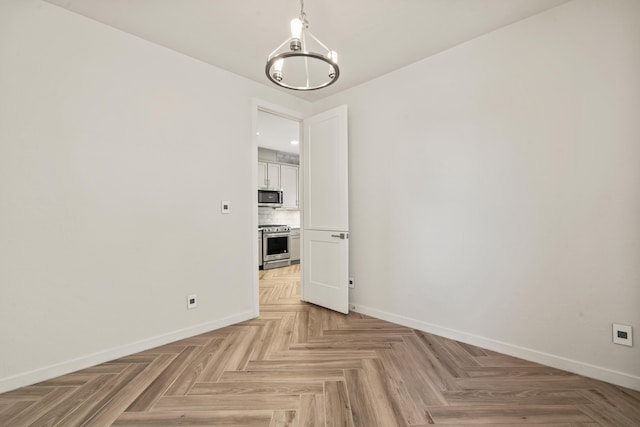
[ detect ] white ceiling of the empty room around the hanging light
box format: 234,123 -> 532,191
46,0 -> 568,101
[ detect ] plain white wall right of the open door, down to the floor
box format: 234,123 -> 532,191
314,0 -> 640,389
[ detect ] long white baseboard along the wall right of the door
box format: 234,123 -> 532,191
353,303 -> 640,391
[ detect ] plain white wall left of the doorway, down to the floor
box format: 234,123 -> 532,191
0,0 -> 310,392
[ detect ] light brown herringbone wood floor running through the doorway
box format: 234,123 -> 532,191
0,265 -> 640,427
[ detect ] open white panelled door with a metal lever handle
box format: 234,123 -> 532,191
301,105 -> 349,313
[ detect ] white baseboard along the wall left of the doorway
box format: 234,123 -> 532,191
0,310 -> 256,393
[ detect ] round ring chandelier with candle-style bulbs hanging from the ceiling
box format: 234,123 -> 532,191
265,0 -> 340,91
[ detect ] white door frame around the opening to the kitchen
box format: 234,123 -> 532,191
250,98 -> 310,317
